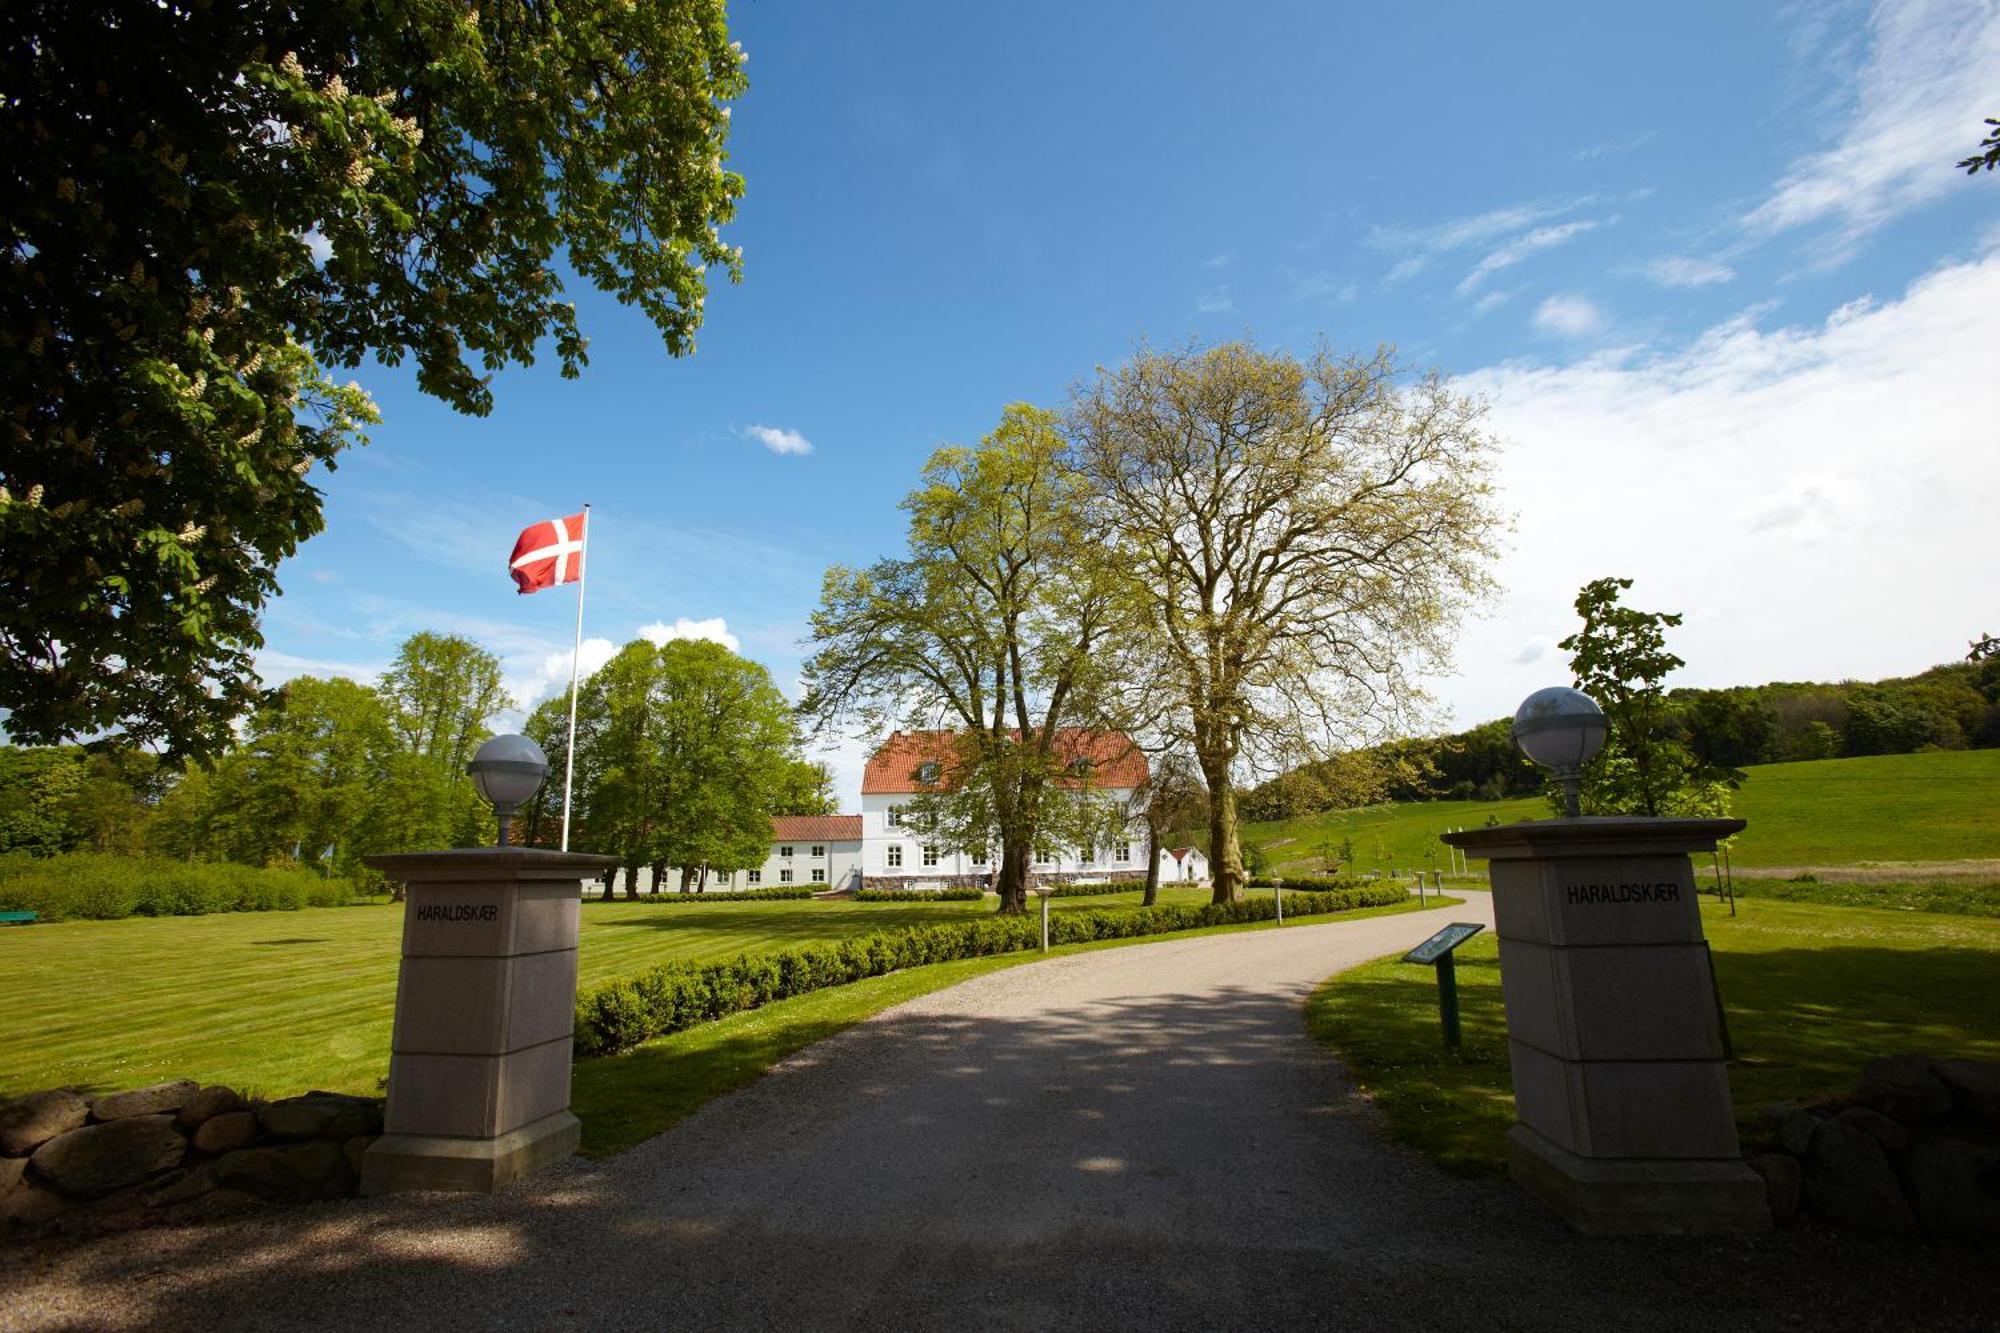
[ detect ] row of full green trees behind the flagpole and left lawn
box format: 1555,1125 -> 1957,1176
0,632 -> 832,887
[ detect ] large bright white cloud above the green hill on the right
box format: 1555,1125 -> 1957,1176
1440,252 -> 2000,723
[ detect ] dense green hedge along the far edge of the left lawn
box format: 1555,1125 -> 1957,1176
0,853 -> 356,921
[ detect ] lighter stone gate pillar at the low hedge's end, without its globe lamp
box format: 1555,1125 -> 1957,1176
362,847 -> 614,1195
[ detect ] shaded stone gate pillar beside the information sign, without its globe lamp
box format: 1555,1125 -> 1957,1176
1444,819 -> 1770,1233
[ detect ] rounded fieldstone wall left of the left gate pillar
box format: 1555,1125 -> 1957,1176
0,1079 -> 382,1229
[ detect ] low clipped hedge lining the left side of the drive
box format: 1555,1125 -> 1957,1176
576,885 -> 1410,1057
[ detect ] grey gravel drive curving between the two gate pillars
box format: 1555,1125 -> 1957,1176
0,895 -> 2000,1333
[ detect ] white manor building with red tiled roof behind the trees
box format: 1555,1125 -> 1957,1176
708,731 -> 1208,893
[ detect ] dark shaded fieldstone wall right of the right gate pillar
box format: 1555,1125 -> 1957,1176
1750,1055 -> 2000,1237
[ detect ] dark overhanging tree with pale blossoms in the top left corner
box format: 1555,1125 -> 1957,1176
0,0 -> 746,757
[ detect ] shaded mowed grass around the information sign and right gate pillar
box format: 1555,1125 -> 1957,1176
1306,899 -> 2000,1175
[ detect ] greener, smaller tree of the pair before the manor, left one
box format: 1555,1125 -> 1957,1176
800,402 -> 1122,913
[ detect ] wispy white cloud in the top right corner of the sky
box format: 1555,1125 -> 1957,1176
1744,0 -> 2000,249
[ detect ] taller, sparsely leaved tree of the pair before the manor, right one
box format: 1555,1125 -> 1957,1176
1068,342 -> 1502,903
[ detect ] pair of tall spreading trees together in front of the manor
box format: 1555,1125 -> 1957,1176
802,342 -> 1502,911
